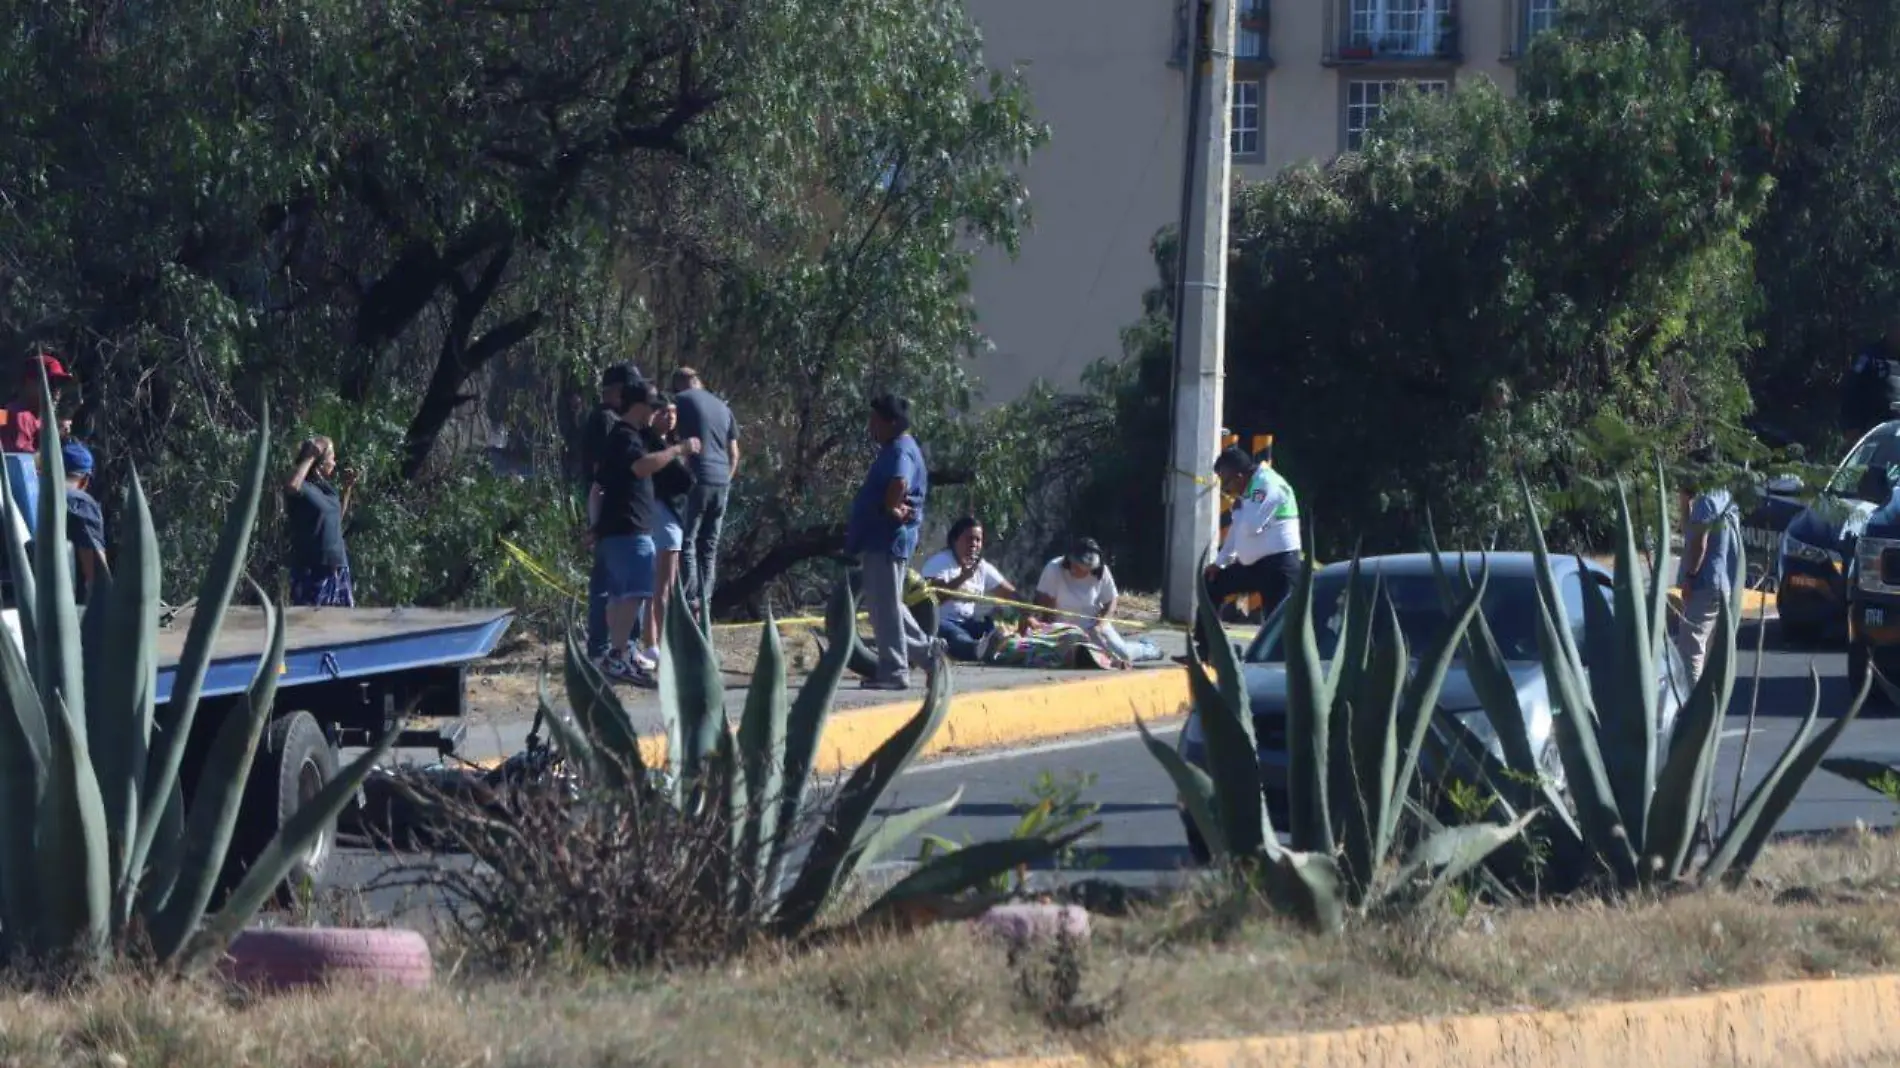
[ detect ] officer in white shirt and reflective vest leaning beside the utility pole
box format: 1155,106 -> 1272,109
1195,445 -> 1305,656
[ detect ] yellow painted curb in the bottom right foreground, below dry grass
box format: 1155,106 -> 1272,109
946,975 -> 1900,1068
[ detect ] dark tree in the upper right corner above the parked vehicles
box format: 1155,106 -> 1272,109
1571,0 -> 1900,444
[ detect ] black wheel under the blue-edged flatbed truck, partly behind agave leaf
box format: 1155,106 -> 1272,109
232,713 -> 336,903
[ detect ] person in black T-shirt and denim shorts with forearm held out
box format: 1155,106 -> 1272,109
593,382 -> 699,684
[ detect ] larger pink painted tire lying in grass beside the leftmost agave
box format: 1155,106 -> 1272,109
222,927 -> 435,990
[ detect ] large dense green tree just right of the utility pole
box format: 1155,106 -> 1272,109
1094,34 -> 1767,559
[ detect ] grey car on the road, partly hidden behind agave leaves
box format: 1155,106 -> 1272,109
1176,553 -> 1687,863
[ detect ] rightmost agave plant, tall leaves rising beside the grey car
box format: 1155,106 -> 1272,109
1427,475 -> 1866,889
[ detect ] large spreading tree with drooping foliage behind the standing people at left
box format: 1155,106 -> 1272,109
0,0 -> 1045,604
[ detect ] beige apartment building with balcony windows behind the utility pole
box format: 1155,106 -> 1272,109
967,0 -> 1560,403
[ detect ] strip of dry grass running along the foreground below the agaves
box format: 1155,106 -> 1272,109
11,834 -> 1900,1068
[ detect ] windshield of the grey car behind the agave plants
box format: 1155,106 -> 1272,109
1246,570 -> 1583,663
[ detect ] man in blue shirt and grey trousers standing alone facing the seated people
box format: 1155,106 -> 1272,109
844,393 -> 937,690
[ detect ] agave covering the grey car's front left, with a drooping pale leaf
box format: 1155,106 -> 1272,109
1136,551 -> 1535,929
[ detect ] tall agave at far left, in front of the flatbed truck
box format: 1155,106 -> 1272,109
0,390 -> 395,971
